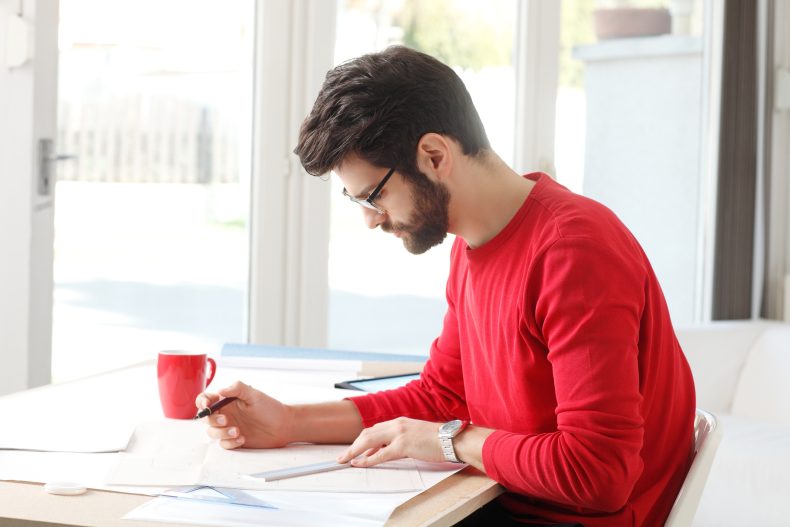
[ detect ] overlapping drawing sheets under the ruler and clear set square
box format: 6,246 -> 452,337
109,420 -> 462,527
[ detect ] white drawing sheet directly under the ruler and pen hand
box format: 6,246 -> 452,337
107,419 -> 424,492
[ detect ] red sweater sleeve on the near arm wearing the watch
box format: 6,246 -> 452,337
483,238 -> 646,512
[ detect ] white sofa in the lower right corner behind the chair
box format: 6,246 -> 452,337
668,321 -> 790,527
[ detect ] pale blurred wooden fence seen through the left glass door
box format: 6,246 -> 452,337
57,95 -> 240,184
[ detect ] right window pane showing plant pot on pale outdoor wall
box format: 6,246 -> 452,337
555,0 -> 713,323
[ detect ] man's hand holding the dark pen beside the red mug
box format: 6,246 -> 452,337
195,381 -> 293,450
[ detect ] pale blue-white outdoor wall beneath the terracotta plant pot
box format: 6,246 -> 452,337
577,36 -> 703,324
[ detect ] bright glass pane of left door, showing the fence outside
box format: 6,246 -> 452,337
52,0 -> 255,381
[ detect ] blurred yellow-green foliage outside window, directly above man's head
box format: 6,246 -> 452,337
396,0 -> 514,70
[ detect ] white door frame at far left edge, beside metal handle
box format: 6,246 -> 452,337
0,0 -> 58,394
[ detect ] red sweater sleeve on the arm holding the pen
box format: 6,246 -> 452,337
350,266 -> 469,427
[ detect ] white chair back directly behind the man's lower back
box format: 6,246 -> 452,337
664,408 -> 722,527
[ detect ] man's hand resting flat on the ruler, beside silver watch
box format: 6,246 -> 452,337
337,417 -> 444,467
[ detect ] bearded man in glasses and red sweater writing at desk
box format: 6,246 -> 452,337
197,47 -> 695,527
